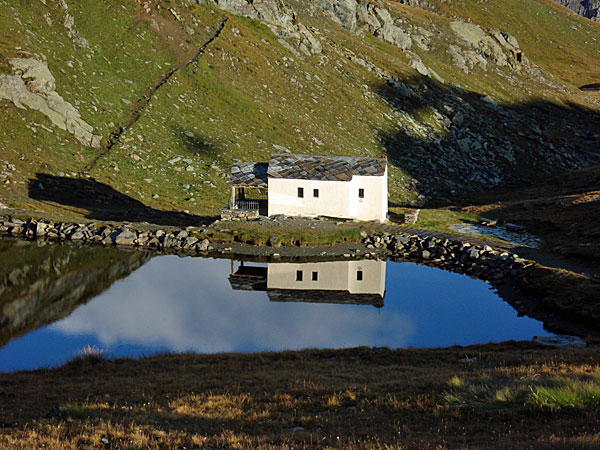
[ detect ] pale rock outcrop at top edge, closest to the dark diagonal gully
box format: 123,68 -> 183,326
191,0 -> 323,55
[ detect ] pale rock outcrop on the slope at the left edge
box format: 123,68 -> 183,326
0,58 -> 102,147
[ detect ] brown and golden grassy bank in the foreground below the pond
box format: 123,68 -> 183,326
0,342 -> 600,449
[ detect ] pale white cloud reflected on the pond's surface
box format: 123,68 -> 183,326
52,256 -> 415,353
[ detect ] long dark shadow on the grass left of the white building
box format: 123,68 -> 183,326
28,173 -> 216,226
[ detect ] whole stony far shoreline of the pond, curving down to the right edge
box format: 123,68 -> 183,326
0,216 -> 600,336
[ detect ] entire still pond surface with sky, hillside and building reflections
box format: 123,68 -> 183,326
0,242 -> 551,371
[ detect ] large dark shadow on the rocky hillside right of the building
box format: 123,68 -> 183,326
373,76 -> 600,205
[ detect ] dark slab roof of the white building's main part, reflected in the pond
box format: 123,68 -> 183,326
267,289 -> 384,308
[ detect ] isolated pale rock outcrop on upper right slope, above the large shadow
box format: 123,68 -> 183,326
449,20 -> 527,73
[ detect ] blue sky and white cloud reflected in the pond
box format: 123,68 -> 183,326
0,256 -> 549,370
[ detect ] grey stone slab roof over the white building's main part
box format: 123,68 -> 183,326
267,153 -> 387,181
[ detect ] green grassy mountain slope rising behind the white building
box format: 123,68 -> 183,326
0,0 -> 600,219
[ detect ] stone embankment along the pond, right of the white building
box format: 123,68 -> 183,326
363,233 -> 533,281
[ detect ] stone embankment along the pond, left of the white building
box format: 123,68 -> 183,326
0,218 -> 213,252
